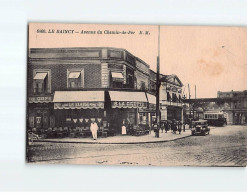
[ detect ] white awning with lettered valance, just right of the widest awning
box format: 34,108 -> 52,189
109,91 -> 148,109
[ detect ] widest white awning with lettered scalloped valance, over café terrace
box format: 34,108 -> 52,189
53,91 -> 105,109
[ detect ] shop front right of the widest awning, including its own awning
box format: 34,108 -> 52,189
107,91 -> 148,134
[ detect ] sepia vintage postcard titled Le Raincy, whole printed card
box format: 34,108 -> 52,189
26,23 -> 247,167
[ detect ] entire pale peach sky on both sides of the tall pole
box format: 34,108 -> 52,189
29,23 -> 247,98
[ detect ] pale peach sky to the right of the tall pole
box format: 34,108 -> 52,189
160,26 -> 247,98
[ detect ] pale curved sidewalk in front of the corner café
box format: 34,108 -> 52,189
36,129 -> 191,144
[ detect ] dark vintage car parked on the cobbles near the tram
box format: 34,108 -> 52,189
191,120 -> 210,135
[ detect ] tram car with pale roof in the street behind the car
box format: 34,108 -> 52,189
204,112 -> 227,126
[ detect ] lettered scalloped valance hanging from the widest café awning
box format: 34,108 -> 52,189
54,102 -> 104,109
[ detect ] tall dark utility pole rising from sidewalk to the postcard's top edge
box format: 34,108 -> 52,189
155,25 -> 160,138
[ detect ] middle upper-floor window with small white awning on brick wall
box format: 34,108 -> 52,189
67,70 -> 84,89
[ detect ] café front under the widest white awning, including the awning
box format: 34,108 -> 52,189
53,91 -> 106,129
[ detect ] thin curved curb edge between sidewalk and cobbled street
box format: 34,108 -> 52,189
34,135 -> 191,144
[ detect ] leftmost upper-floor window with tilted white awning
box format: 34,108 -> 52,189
33,70 -> 50,94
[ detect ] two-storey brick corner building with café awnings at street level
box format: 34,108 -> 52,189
27,48 -> 158,133
